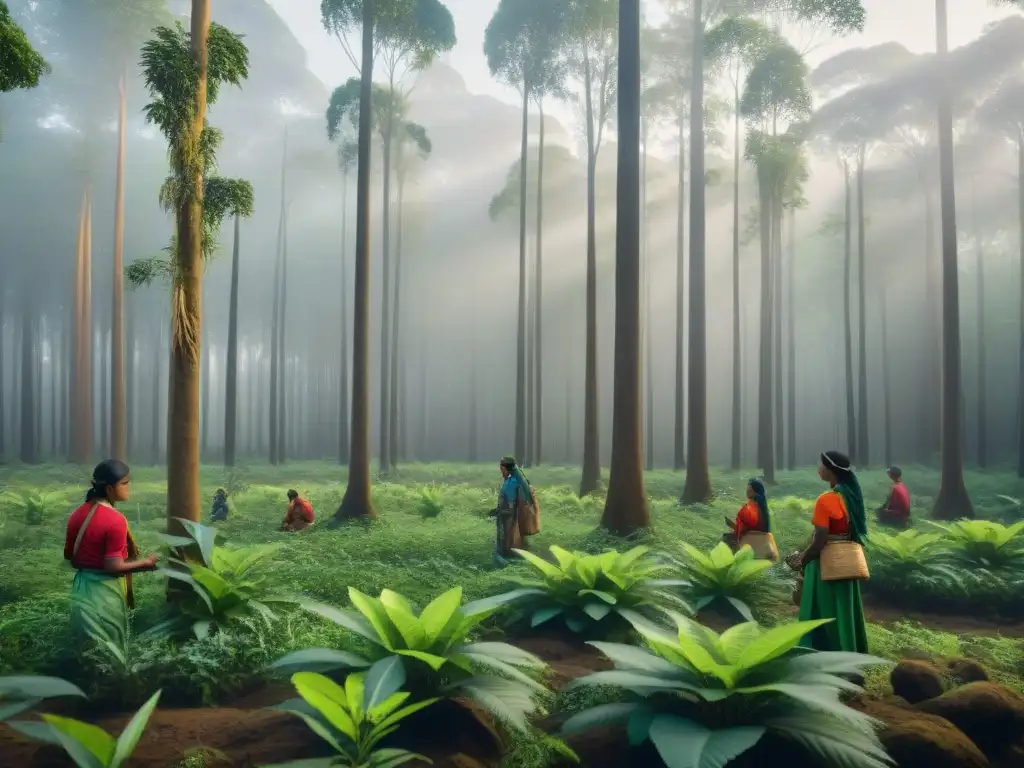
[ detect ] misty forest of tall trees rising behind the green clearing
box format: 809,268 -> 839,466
0,0 -> 1024,529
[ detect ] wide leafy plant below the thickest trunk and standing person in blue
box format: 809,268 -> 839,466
477,546 -> 690,634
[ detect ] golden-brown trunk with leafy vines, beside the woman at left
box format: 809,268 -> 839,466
167,0 -> 210,536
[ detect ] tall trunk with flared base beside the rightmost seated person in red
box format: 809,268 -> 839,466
932,0 -> 974,520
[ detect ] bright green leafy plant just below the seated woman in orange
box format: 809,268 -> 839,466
680,542 -> 779,622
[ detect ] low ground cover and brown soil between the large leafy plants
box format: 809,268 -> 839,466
0,463 -> 1024,768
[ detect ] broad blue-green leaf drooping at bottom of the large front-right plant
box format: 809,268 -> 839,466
649,715 -> 767,768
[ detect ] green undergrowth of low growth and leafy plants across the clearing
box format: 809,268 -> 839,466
0,464 -> 1024,768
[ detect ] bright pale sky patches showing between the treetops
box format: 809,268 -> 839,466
269,0 -> 1009,109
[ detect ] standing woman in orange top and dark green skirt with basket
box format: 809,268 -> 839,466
793,451 -> 867,653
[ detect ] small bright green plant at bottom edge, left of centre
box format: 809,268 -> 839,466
268,672 -> 437,768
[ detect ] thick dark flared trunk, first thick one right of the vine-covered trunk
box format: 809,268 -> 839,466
335,0 -> 377,519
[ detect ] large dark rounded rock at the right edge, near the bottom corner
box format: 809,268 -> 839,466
918,683 -> 1024,757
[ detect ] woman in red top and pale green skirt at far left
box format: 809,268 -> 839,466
65,459 -> 158,646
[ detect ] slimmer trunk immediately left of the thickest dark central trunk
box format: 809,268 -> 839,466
580,48 -> 601,496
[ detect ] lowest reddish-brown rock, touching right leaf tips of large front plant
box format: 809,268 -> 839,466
854,698 -> 990,768
